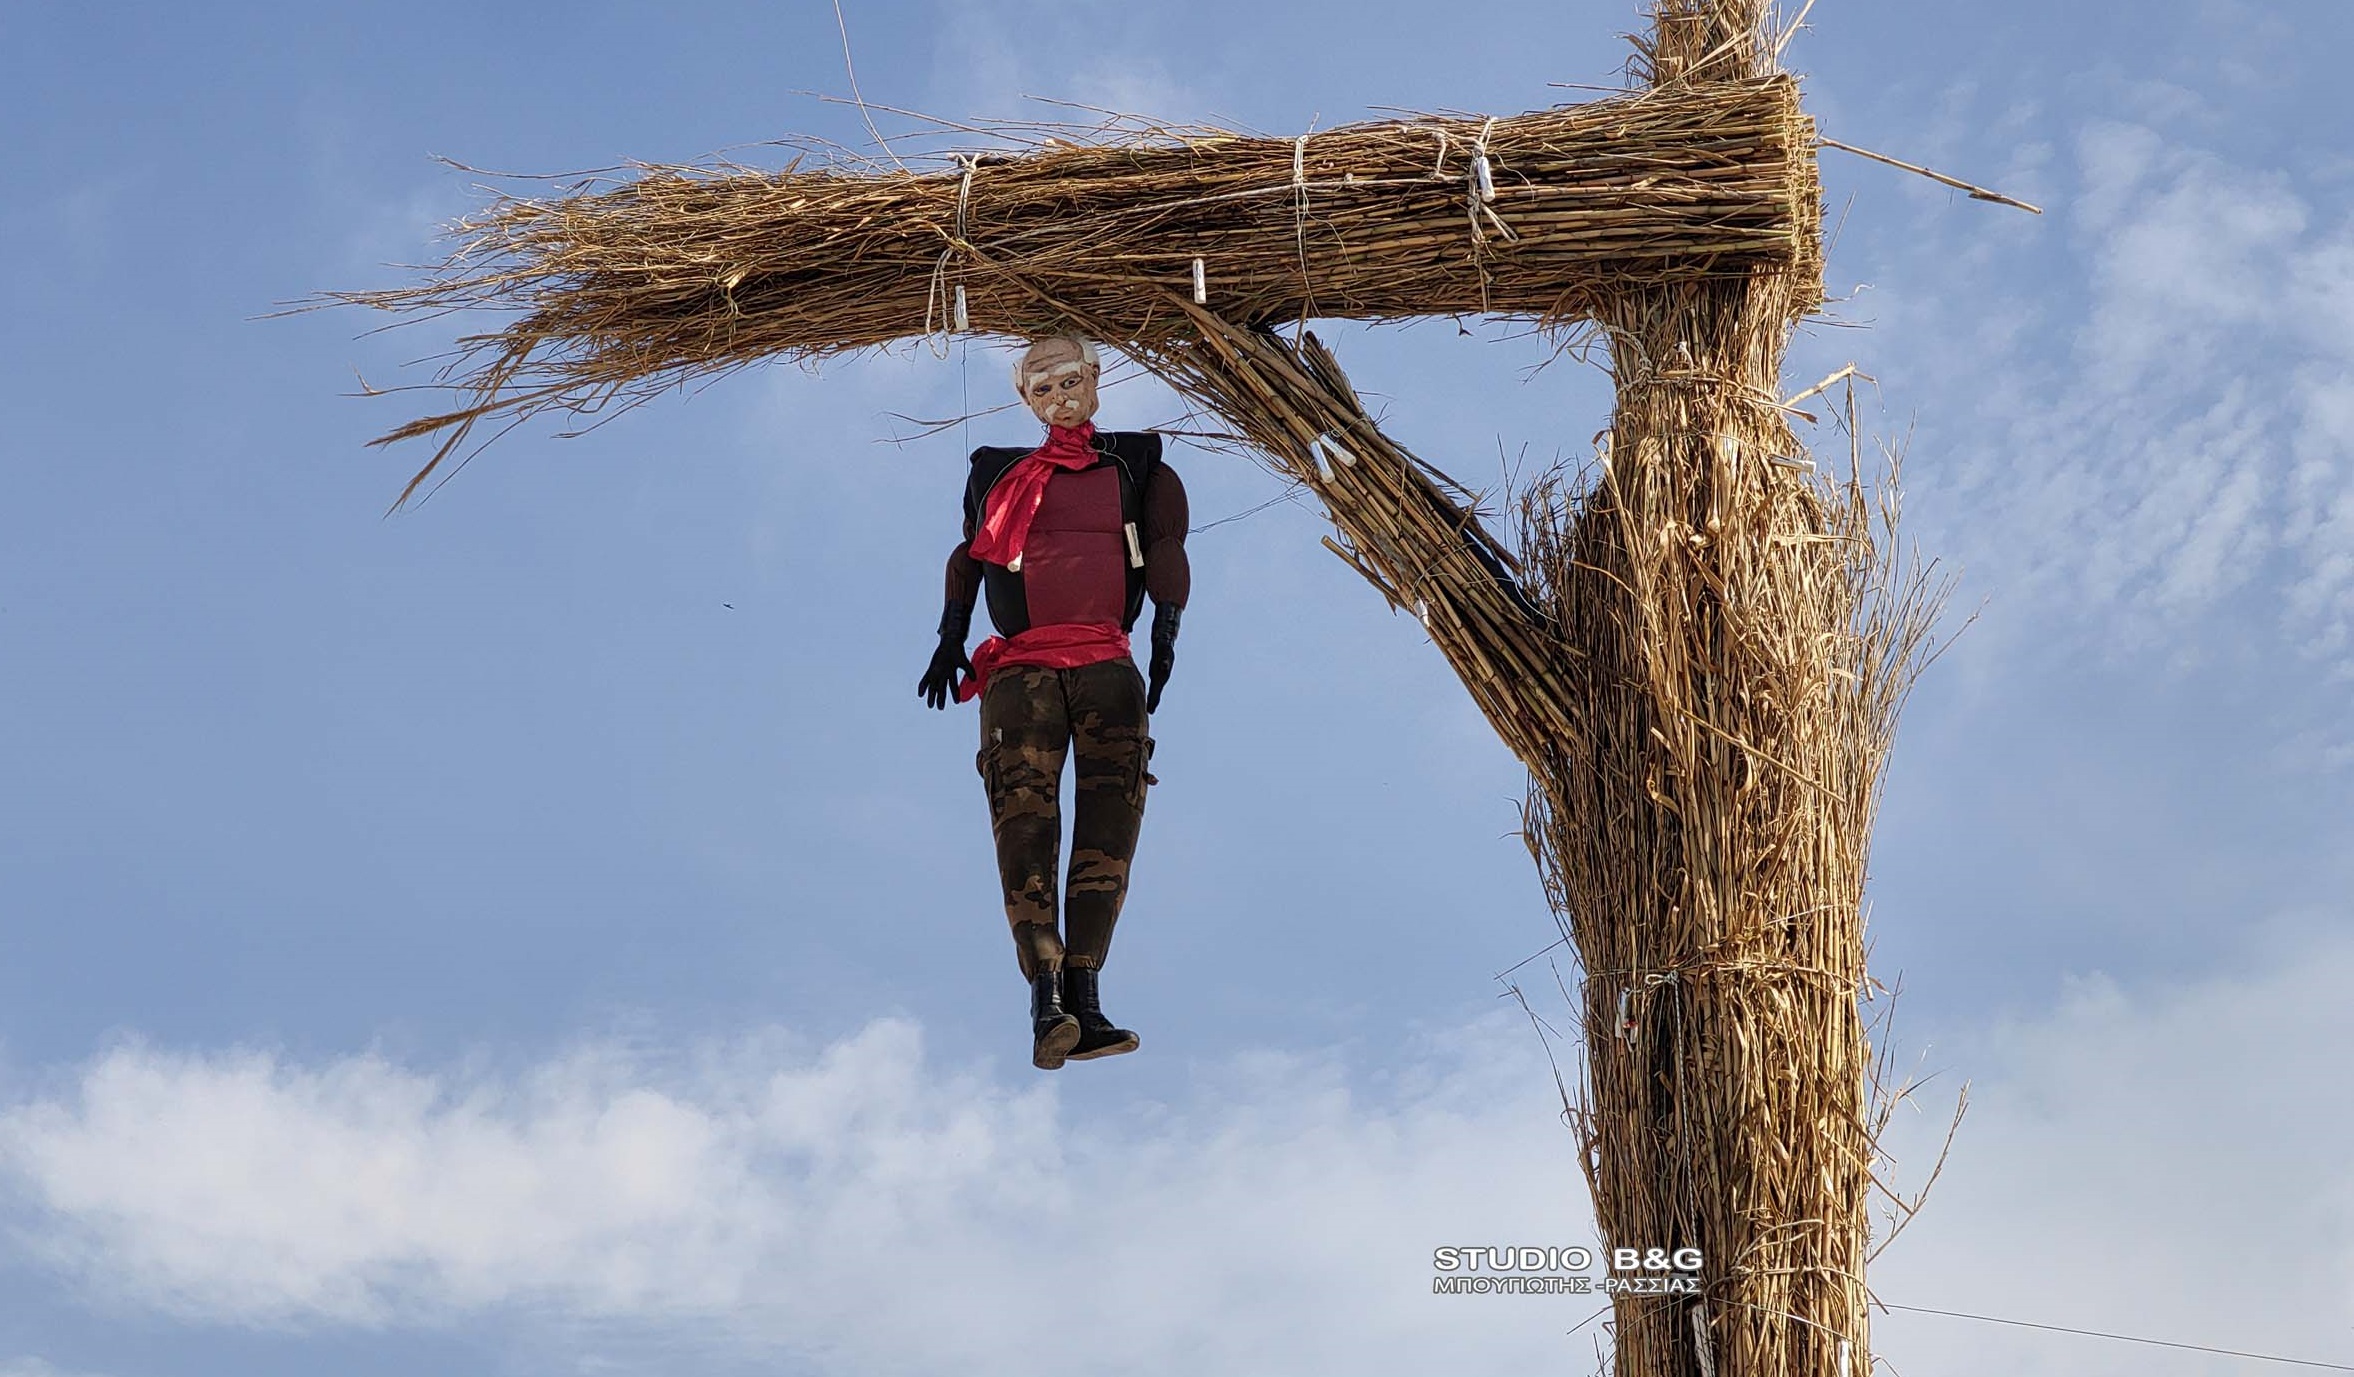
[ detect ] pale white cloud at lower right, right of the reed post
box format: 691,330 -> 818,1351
1874,934 -> 2354,1377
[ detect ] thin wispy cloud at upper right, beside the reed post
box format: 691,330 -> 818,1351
1826,120 -> 2354,673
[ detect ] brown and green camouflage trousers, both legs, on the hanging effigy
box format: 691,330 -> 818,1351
977,659 -> 1153,979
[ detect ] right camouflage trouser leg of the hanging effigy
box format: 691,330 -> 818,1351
1064,659 -> 1151,970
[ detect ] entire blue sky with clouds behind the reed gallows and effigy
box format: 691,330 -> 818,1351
0,0 -> 2354,1377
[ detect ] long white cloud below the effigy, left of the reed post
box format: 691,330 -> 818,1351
0,1002 -> 1591,1372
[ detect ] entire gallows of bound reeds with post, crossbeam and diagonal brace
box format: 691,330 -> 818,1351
334,0 -> 1935,1377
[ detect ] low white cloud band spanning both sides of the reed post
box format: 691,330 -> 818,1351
0,937 -> 2354,1377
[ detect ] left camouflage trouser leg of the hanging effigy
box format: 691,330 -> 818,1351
975,666 -> 1071,979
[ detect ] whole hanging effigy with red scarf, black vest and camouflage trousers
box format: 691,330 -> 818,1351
916,337 -> 1193,1071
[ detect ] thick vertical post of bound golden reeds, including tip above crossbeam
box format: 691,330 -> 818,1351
1532,0 -> 1904,1377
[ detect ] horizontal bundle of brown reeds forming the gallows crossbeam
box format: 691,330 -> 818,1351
330,78 -> 1820,503
